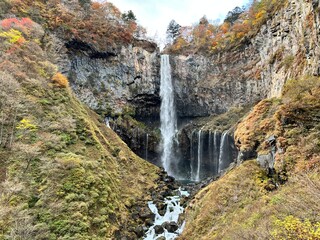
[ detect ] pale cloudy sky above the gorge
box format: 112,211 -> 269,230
108,0 -> 249,43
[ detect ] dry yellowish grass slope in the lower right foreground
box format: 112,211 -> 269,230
180,161 -> 320,240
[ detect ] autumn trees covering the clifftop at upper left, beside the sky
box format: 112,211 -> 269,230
0,0 -> 145,51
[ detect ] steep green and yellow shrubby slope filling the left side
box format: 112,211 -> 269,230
0,18 -> 157,239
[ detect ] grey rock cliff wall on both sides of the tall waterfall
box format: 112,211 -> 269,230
47,0 -> 320,180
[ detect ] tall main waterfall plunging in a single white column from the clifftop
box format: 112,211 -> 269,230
160,55 -> 177,175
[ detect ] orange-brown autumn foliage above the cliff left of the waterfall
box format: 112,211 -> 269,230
2,0 -> 137,51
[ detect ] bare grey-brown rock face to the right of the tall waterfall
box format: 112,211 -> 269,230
171,0 -> 320,117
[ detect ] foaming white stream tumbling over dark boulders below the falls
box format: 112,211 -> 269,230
144,189 -> 189,240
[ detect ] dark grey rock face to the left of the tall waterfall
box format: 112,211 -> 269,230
61,40 -> 160,117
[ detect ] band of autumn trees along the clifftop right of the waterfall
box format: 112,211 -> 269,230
165,0 -> 287,55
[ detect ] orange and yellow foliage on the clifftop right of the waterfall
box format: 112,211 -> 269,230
169,0 -> 287,52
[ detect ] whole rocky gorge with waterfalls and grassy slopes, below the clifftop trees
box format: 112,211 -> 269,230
0,0 -> 320,240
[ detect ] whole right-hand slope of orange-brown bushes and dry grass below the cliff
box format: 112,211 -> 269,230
181,76 -> 320,239
